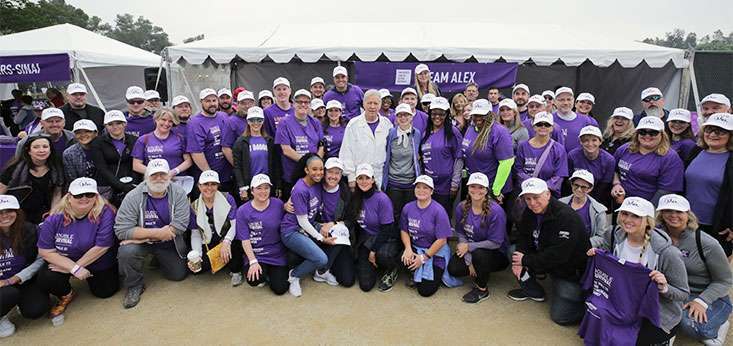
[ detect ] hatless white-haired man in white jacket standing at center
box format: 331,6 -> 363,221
339,89 -> 392,190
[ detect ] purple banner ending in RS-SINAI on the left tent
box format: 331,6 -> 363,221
0,54 -> 71,83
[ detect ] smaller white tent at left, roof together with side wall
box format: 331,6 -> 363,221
0,24 -> 161,109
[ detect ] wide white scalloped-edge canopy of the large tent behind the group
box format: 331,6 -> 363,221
167,23 -> 687,68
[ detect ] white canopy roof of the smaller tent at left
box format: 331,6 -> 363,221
0,24 -> 160,68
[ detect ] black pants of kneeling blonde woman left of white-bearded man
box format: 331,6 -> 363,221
38,264 -> 120,298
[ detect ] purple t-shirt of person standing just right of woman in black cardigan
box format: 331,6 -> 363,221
275,116 -> 323,183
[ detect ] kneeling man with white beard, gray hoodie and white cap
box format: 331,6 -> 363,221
114,159 -> 191,309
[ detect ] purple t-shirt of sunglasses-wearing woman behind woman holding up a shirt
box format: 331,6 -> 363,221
614,143 -> 684,200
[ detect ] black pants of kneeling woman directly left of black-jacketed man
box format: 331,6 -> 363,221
448,249 -> 509,288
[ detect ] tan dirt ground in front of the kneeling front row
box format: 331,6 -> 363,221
0,264 -> 733,345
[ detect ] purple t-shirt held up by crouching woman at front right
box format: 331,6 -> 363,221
578,251 -> 660,345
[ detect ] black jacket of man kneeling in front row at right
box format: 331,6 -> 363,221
517,197 -> 591,281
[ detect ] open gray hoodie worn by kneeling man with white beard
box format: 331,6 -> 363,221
115,182 -> 191,258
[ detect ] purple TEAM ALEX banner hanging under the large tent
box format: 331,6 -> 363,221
354,62 -> 517,93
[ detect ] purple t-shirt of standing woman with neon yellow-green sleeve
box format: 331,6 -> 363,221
461,126 -> 514,192
